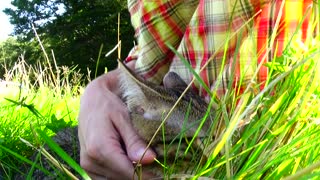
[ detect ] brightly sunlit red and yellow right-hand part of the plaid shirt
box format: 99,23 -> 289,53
254,0 -> 312,89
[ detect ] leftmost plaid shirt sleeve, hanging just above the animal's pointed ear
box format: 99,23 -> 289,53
128,0 -> 198,84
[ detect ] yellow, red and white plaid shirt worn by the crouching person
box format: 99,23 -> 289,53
127,0 -> 312,96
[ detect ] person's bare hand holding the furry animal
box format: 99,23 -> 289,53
78,62 -> 155,179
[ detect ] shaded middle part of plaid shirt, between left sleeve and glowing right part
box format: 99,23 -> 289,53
170,0 -> 256,96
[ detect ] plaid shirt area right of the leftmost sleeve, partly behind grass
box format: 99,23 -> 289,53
170,0 -> 312,96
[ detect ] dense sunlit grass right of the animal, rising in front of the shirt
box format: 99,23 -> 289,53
156,38 -> 320,179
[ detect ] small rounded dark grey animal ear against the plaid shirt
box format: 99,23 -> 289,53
163,72 -> 188,89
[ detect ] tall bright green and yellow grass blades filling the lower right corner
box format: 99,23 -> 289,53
198,47 -> 320,179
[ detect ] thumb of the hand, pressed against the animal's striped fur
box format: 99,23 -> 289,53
114,113 -> 156,164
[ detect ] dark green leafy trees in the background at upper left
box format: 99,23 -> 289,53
4,0 -> 134,77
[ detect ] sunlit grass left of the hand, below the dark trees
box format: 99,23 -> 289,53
0,52 -> 84,179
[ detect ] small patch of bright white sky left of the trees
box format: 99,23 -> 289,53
0,0 -> 13,41
